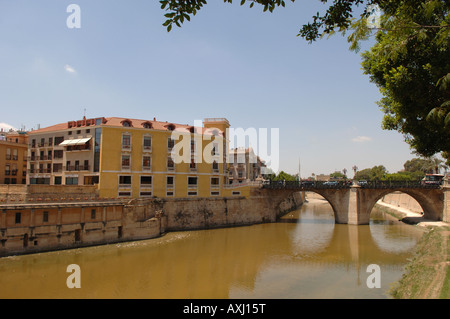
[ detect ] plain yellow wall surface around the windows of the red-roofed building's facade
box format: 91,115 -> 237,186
99,126 -> 231,198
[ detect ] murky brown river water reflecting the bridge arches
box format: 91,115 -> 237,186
0,198 -> 422,299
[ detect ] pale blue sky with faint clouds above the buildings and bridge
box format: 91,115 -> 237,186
0,0 -> 422,177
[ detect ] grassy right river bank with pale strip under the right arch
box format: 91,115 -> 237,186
377,201 -> 450,299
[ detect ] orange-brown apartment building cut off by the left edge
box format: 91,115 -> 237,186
0,131 -> 28,184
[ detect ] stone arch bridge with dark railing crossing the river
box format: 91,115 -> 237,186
262,182 -> 450,225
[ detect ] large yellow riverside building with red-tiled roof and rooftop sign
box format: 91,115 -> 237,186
28,117 -> 253,198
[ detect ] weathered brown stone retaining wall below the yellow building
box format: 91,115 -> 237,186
0,187 -> 305,257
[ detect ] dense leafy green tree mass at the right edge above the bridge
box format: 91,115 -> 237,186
362,0 -> 450,165
